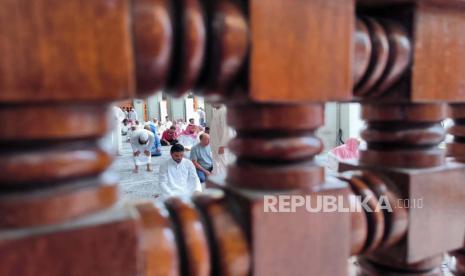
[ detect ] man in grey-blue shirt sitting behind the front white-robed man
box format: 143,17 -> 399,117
191,133 -> 213,183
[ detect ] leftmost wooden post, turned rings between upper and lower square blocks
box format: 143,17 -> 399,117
0,0 -> 150,276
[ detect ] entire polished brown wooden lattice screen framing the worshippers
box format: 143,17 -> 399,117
0,0 -> 465,276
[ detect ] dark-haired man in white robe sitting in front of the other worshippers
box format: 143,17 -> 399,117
159,144 -> 202,198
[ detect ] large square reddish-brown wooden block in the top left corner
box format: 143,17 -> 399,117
0,0 -> 133,103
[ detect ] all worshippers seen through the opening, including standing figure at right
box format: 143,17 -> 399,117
112,105 -> 234,197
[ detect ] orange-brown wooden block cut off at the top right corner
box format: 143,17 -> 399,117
411,2 -> 465,102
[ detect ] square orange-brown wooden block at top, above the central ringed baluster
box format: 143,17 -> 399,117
249,0 -> 355,102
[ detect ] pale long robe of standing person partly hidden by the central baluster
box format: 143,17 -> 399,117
210,105 -> 234,175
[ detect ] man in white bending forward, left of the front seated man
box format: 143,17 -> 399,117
131,129 -> 155,173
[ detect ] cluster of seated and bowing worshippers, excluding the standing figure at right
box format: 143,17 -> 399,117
123,115 -> 213,195
